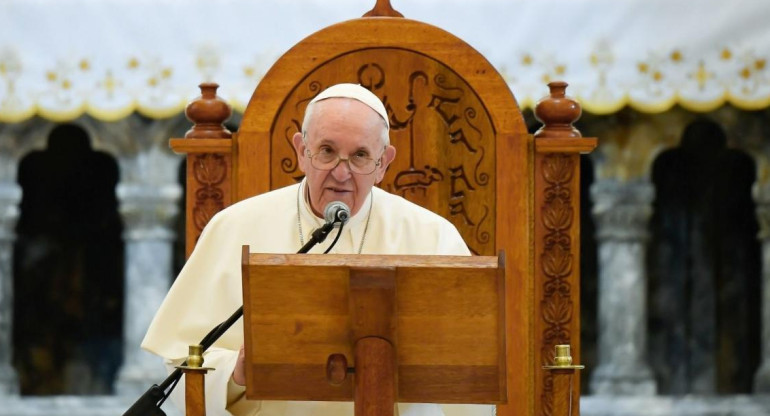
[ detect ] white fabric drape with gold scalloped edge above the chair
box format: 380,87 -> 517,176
0,0 -> 770,123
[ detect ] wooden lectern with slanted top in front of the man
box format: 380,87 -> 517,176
242,246 -> 507,416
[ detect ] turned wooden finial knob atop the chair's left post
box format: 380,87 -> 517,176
184,82 -> 233,139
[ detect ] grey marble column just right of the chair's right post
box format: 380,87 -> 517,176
591,180 -> 656,395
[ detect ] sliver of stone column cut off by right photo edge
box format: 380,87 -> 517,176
754,184 -> 770,393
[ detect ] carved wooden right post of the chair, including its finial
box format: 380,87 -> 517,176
534,81 -> 596,416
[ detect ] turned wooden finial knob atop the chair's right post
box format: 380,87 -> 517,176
535,81 -> 582,138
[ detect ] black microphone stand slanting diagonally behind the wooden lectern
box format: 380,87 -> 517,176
123,222 -> 344,416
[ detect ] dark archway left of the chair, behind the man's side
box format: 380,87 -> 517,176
13,124 -> 124,395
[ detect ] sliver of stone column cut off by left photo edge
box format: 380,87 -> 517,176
0,182 -> 21,397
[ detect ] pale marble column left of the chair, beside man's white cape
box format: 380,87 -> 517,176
116,183 -> 181,396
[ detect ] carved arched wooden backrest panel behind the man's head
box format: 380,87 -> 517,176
270,48 -> 498,255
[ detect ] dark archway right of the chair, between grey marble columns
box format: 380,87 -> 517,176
648,120 -> 761,395
